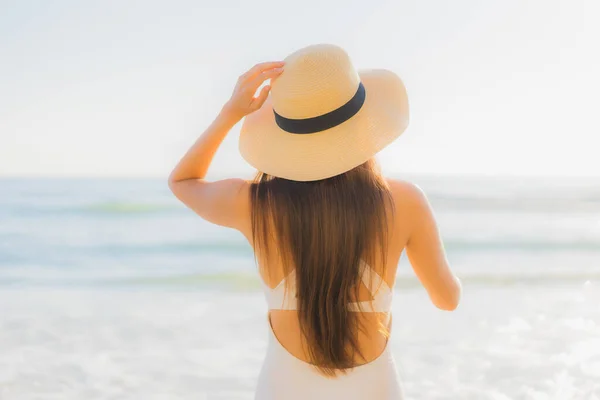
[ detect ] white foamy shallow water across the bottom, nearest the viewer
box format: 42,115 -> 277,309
0,285 -> 600,400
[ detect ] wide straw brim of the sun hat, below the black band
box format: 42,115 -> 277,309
239,69 -> 409,181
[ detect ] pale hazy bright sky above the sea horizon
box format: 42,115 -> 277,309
0,0 -> 600,177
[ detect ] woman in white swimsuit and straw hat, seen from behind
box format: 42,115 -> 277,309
169,45 -> 461,400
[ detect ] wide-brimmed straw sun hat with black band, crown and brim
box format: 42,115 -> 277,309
239,44 -> 408,181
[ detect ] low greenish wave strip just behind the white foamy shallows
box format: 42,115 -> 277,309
0,260 -> 600,290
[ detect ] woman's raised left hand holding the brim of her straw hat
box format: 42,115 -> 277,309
221,61 -> 284,122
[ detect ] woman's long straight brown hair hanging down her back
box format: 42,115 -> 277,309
250,159 -> 393,376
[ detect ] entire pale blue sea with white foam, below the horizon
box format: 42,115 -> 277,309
0,176 -> 600,400
